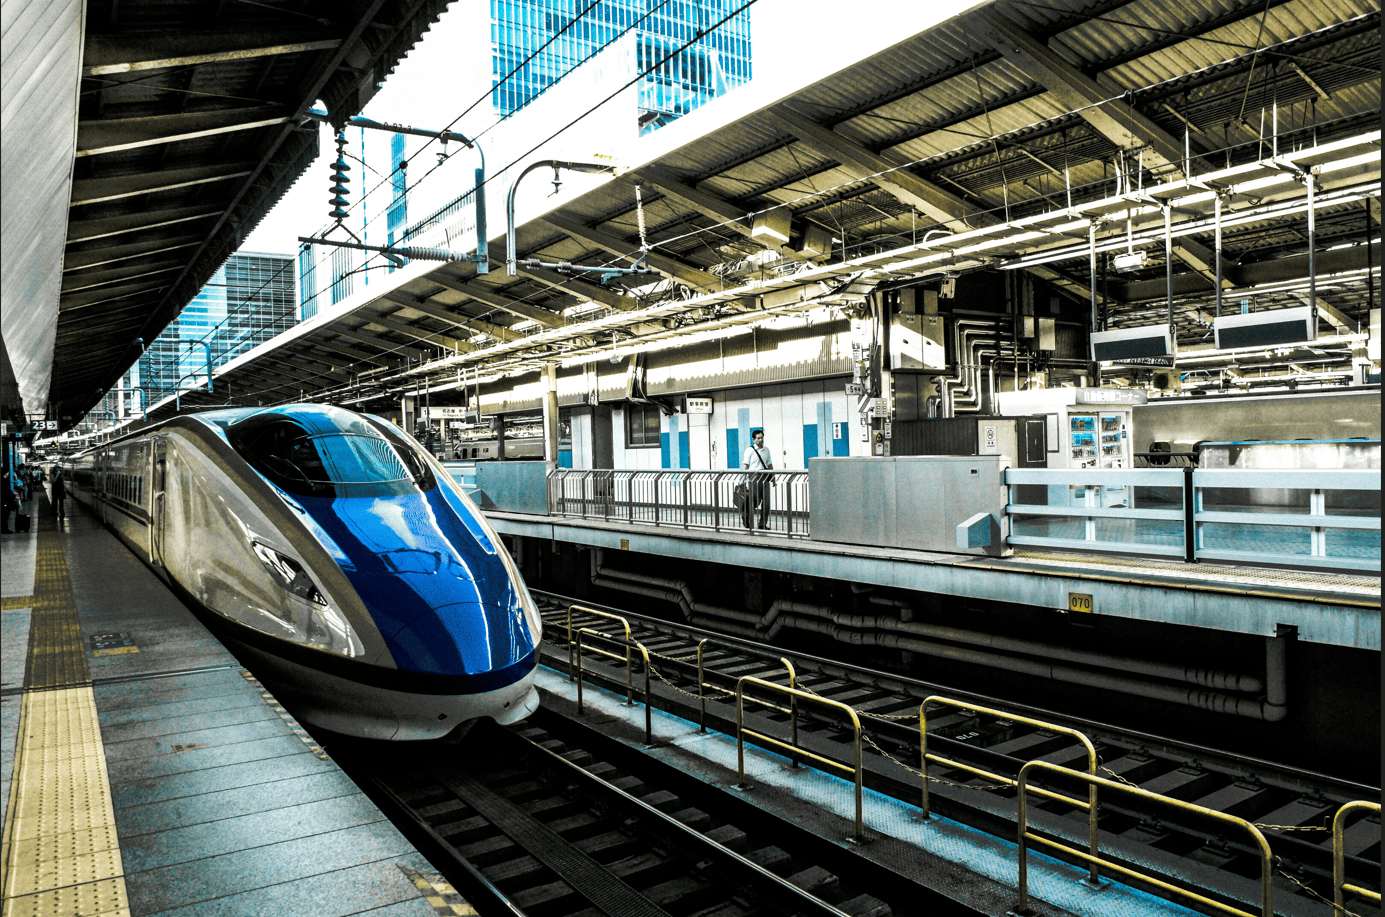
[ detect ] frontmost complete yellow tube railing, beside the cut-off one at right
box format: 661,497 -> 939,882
1015,760 -> 1274,917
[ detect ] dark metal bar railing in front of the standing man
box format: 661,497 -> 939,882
548,468 -> 809,537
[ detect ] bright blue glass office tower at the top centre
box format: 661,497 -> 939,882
490,0 -> 751,132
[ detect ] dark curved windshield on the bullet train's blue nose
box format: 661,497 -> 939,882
227,414 -> 436,497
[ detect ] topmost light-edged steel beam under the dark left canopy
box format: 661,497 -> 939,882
82,28 -> 342,76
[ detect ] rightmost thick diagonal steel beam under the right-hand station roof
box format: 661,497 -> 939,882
976,10 -> 1202,172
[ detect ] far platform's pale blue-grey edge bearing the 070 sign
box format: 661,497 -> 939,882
486,510 -> 1381,652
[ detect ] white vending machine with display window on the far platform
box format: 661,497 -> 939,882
997,388 -> 1148,506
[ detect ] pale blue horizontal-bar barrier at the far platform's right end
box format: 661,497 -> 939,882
1006,467 -> 1381,572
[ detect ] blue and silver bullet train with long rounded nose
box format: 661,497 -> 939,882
65,404 -> 542,740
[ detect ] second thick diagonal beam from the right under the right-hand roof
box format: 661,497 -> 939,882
774,105 -> 996,230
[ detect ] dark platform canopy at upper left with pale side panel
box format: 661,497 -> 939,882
4,0 -> 447,427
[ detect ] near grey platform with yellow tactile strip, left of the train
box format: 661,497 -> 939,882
0,504 -> 462,917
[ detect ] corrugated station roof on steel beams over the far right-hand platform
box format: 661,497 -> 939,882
5,0 -> 1381,434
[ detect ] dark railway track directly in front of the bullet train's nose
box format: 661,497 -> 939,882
337,711 -> 972,917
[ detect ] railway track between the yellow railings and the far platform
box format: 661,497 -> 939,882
535,591 -> 1381,917
